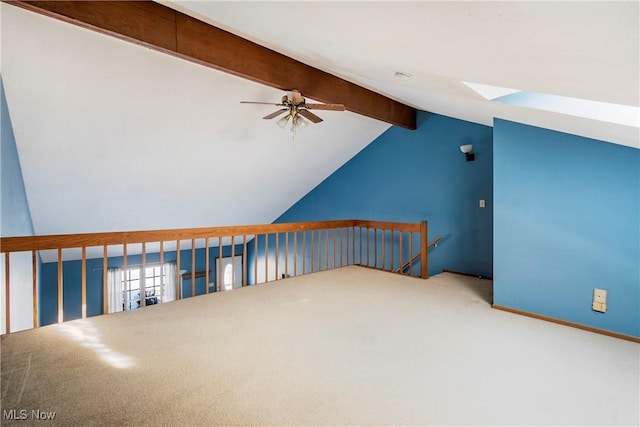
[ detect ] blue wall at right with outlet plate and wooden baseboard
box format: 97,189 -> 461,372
493,119 -> 640,337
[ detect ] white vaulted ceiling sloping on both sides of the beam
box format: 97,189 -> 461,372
1,1 -> 640,234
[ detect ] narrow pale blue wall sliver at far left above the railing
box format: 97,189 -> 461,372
0,77 -> 33,237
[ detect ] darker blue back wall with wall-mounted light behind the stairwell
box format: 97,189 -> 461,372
276,112 -> 493,277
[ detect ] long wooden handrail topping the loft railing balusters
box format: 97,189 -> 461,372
0,219 -> 420,253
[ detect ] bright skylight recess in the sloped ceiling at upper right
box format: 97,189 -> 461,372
463,82 -> 640,128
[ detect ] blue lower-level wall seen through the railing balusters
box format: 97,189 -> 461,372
39,245 -> 243,325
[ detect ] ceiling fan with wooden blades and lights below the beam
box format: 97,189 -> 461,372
240,90 -> 345,133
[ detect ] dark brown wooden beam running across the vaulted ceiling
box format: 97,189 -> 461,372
5,0 -> 416,129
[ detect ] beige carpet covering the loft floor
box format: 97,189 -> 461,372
1,267 -> 640,426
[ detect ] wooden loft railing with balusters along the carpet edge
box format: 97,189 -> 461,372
0,220 -> 428,333
